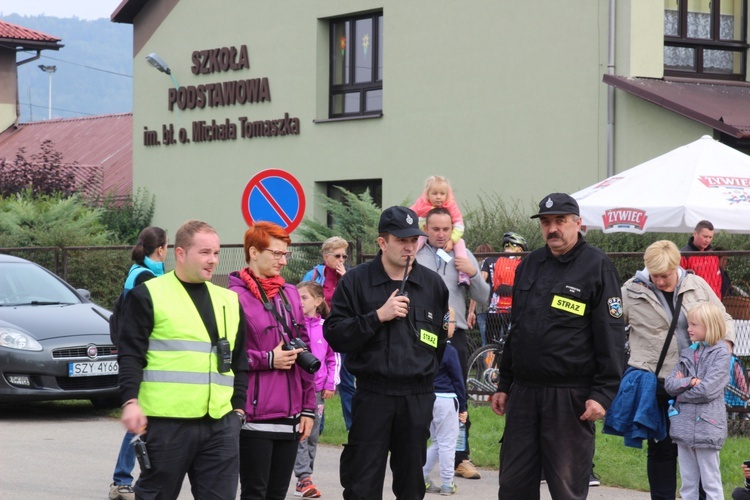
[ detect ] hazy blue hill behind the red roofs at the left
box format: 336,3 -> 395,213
0,14 -> 132,122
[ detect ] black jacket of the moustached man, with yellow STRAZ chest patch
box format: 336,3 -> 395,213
498,236 -> 625,409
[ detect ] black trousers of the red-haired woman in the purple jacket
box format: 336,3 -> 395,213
241,431 -> 299,500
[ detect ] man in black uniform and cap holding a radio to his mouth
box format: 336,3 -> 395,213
323,206 -> 448,499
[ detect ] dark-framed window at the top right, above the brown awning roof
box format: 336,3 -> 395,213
664,0 -> 748,80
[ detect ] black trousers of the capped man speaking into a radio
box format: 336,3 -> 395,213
340,388 -> 435,500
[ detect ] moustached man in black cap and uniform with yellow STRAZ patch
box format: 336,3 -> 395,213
492,193 -> 625,499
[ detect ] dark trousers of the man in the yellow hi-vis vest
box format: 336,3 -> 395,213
133,412 -> 241,500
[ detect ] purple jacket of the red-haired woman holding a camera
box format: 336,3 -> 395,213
229,272 -> 316,421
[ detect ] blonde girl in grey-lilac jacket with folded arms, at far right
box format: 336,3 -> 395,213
664,302 -> 730,500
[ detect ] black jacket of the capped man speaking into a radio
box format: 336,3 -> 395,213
323,253 -> 448,396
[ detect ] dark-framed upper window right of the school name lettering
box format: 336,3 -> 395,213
329,13 -> 383,118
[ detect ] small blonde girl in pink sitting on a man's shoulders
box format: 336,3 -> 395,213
411,175 -> 470,286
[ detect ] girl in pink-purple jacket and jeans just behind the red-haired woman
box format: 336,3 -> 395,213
294,281 -> 341,498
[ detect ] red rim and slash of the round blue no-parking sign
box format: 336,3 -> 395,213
242,168 -> 305,233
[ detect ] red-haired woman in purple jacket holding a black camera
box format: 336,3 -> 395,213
229,222 -> 316,500
